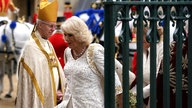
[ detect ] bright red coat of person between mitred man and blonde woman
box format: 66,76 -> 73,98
49,33 -> 68,68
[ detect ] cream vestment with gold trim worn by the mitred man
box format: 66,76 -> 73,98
16,32 -> 65,108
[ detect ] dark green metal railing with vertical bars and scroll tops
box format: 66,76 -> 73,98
104,0 -> 192,108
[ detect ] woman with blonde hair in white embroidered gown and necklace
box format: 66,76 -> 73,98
59,16 -> 122,108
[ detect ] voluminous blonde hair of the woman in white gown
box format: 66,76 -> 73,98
61,16 -> 93,45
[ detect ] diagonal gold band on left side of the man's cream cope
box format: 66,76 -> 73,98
20,58 -> 44,105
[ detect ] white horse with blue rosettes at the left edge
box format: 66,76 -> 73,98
0,19 -> 33,97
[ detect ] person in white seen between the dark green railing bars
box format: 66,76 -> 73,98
131,23 -> 163,108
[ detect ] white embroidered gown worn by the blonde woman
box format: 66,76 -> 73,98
59,44 -> 122,108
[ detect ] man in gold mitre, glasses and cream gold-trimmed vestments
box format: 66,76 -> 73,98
16,0 -> 65,108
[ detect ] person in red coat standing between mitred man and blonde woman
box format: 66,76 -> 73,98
49,17 -> 68,68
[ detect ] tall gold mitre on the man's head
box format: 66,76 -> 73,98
38,0 -> 58,22
